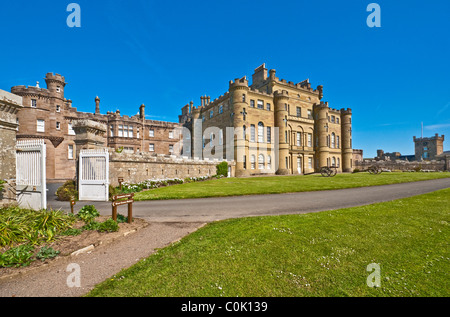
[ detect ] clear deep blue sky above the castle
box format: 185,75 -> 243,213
0,0 -> 450,157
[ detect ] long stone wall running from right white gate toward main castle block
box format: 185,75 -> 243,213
109,151 -> 235,187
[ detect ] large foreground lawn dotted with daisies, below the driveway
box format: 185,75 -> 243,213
88,186 -> 450,297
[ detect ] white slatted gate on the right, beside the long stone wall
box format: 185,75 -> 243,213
78,149 -> 109,201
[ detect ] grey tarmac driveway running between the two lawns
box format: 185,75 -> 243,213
50,178 -> 450,222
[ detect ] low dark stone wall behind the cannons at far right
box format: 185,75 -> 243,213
354,160 -> 450,171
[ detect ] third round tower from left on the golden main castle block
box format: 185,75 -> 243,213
314,101 -> 330,168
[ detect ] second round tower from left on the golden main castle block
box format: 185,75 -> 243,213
274,90 -> 290,175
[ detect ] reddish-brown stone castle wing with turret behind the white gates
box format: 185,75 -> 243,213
11,73 -> 181,182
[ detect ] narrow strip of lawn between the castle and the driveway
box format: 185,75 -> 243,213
134,172 -> 450,200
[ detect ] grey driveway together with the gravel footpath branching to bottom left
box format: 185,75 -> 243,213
0,178 -> 450,297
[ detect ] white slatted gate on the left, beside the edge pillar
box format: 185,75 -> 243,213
16,140 -> 47,210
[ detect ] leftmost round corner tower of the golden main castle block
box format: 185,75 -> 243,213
229,77 -> 250,177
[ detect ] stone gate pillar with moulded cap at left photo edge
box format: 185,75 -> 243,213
0,90 -> 23,205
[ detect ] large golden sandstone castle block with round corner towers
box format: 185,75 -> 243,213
179,64 -> 353,176
